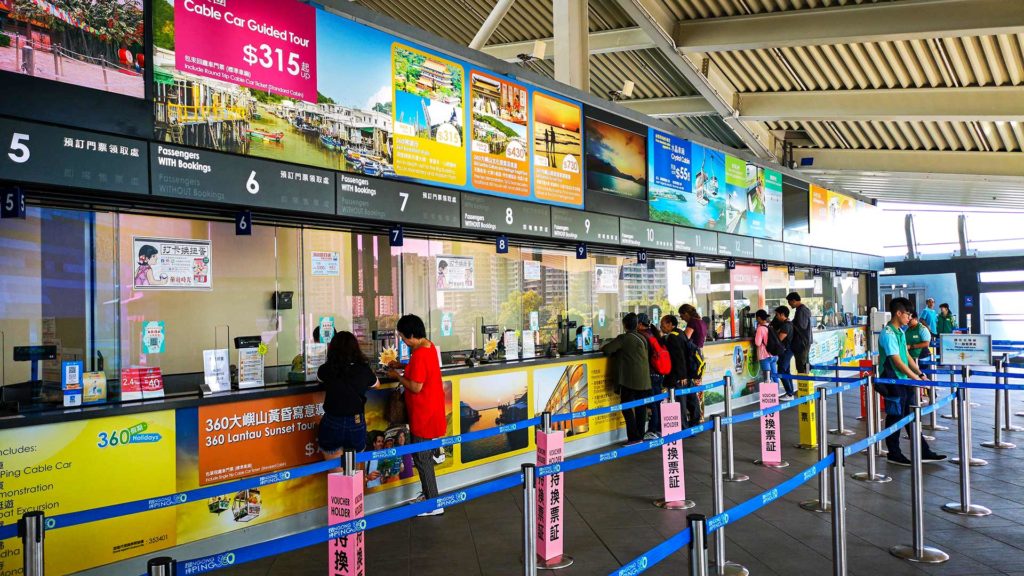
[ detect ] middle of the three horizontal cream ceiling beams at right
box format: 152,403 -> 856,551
737,84 -> 1024,122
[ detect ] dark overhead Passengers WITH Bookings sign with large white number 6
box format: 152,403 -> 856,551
150,143 -> 335,214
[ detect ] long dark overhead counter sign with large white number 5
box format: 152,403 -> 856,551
0,118 -> 150,194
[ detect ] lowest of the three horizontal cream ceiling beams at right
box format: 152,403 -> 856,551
793,148 -> 1024,177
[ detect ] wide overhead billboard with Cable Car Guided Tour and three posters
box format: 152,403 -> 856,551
154,0 -> 584,208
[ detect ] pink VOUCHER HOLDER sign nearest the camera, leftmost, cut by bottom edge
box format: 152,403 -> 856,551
327,470 -> 367,576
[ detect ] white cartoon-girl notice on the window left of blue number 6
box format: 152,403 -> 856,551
132,237 -> 213,290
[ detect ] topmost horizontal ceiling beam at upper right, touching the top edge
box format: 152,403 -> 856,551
673,0 -> 1024,52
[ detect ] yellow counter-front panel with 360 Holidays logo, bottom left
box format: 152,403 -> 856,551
0,410 -> 175,574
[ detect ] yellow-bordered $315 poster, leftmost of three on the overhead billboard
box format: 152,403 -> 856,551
391,43 -> 466,186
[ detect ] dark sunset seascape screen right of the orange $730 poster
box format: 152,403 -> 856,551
586,118 -> 647,200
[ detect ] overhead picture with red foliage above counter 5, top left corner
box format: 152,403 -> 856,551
0,0 -> 145,98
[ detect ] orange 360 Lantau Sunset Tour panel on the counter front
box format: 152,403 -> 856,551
199,393 -> 324,486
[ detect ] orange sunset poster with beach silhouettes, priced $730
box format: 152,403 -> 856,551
534,91 -> 583,206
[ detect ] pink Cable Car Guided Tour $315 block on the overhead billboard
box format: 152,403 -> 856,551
174,0 -> 316,102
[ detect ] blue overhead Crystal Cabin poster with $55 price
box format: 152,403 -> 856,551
648,130 -> 726,232
